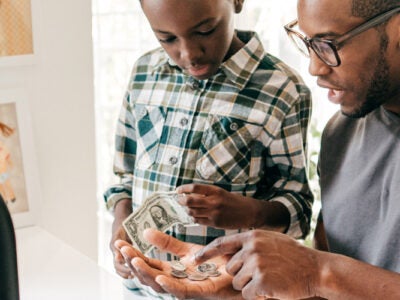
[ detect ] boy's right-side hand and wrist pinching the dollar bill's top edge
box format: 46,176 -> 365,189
176,184 -> 265,229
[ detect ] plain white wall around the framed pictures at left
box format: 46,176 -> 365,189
0,0 -> 97,259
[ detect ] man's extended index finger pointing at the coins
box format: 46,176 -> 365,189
194,233 -> 246,263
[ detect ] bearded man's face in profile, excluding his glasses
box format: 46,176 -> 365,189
298,0 -> 400,117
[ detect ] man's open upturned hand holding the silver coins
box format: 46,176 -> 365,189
115,229 -> 241,299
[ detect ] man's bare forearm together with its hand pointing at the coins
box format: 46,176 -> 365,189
195,230 -> 400,300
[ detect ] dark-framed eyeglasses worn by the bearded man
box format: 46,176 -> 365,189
285,7 -> 400,67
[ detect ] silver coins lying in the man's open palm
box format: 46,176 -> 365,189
170,260 -> 221,281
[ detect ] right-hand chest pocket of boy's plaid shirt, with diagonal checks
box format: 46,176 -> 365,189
196,115 -> 262,184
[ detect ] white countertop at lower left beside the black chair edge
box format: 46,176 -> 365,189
16,226 -> 145,300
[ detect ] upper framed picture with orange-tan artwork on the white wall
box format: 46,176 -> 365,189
0,0 -> 34,66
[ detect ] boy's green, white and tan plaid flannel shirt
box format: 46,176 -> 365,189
104,31 -> 313,252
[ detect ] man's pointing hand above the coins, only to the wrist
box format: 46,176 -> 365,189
195,230 -> 323,299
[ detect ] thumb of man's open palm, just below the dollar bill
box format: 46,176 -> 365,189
143,228 -> 196,256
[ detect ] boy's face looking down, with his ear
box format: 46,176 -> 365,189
141,0 -> 243,79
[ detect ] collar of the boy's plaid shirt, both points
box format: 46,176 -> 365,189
152,30 -> 265,90
